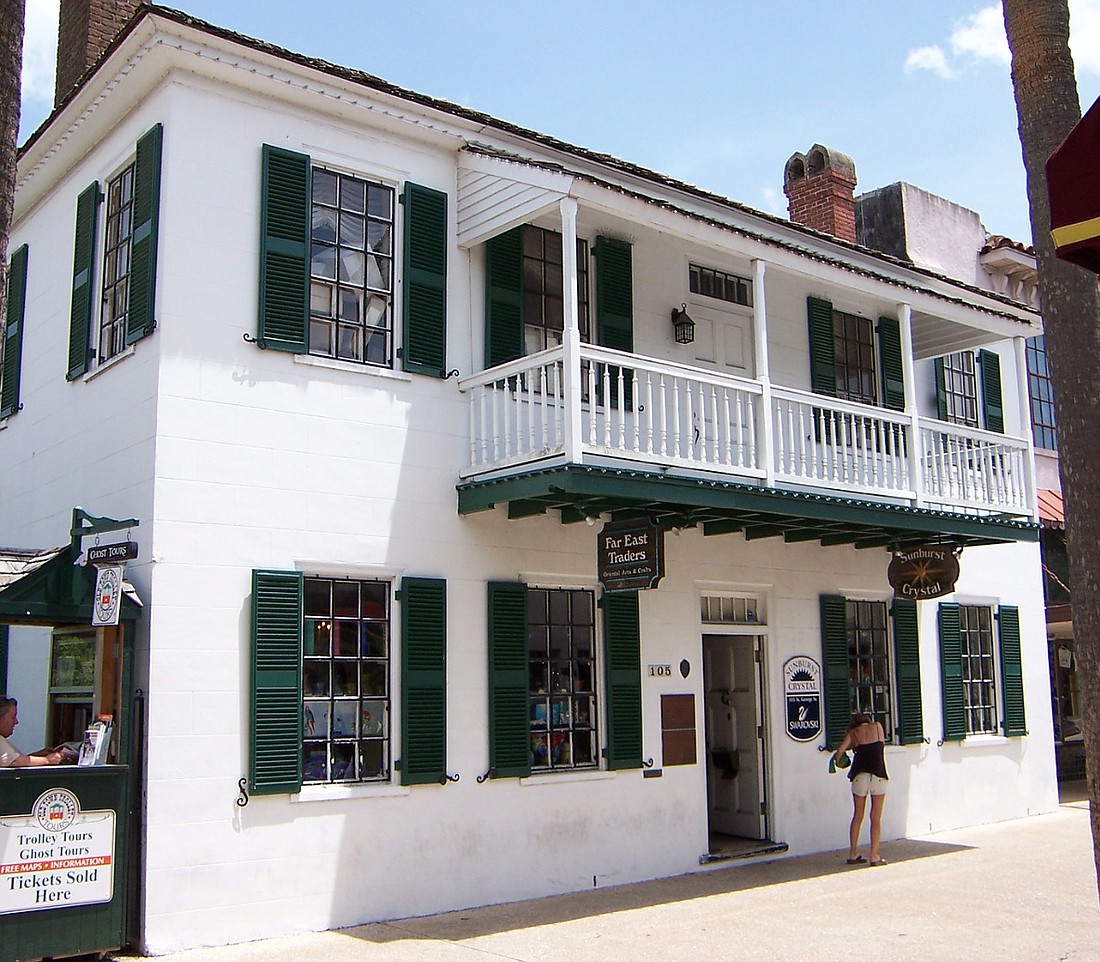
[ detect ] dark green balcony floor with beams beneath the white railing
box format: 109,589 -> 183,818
458,464 -> 1038,549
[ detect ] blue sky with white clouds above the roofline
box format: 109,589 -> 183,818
20,0 -> 1100,243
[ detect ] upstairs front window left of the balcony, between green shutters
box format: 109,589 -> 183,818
309,167 -> 394,367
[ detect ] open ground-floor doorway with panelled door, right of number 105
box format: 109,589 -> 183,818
703,634 -> 767,839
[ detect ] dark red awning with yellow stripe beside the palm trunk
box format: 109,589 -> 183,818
1046,98 -> 1100,274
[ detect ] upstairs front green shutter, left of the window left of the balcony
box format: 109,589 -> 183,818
257,144 -> 310,354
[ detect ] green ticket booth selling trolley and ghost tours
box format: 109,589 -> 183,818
0,508 -> 144,962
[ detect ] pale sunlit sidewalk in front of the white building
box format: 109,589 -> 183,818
119,792 -> 1100,962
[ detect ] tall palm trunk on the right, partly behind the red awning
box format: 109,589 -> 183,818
1003,0 -> 1100,897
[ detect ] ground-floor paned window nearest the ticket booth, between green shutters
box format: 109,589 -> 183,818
301,578 -> 391,782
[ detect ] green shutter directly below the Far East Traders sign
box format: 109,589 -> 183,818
603,591 -> 641,770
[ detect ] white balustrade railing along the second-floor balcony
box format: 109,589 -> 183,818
460,344 -> 1034,517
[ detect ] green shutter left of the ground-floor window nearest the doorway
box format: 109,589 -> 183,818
488,582 -> 531,778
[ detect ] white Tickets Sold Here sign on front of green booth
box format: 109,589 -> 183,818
0,788 -> 114,915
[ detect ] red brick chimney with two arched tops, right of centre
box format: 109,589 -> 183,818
783,144 -> 856,244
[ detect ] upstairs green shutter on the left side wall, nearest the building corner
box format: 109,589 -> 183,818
127,124 -> 163,344
